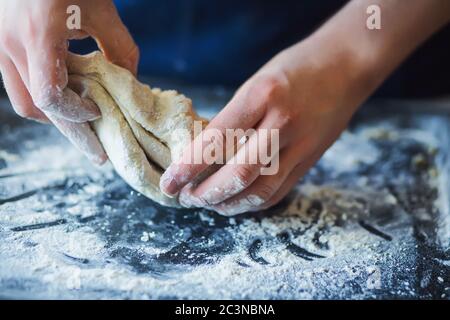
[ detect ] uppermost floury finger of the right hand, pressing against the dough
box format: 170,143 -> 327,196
160,87 -> 265,196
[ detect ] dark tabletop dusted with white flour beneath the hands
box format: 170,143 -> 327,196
0,83 -> 450,299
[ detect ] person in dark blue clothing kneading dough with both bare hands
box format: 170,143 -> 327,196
0,0 -> 450,215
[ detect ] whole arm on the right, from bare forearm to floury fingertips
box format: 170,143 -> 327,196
160,0 -> 450,215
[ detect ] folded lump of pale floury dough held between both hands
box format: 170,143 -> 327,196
67,52 -> 206,207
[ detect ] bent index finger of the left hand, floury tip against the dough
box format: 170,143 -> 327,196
27,39 -> 100,122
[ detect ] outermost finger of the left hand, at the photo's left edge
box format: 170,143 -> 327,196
0,57 -> 49,123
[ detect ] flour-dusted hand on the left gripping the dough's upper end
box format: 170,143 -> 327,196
0,0 -> 139,164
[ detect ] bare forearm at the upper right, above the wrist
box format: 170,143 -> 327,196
310,0 -> 450,87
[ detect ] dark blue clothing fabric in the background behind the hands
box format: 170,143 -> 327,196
71,0 -> 450,96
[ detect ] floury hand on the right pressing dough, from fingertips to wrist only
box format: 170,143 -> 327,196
161,40 -> 373,215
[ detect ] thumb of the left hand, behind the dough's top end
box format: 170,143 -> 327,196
85,2 -> 139,75
